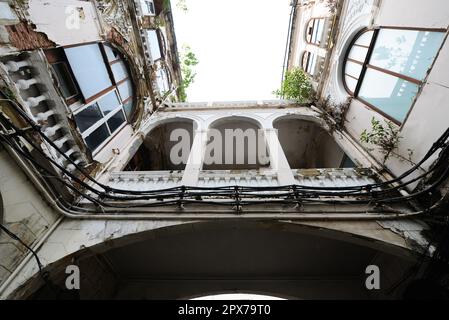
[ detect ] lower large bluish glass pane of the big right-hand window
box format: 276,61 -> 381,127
359,69 -> 419,122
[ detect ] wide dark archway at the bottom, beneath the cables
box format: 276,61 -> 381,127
14,220 -> 416,299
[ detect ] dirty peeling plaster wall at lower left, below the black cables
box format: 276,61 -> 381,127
0,147 -> 58,285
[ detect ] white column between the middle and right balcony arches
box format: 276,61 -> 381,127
265,128 -> 296,185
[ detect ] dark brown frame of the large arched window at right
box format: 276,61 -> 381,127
342,26 -> 447,126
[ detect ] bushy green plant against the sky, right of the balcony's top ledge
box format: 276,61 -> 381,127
273,68 -> 313,103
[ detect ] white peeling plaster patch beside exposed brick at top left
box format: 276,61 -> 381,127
28,0 -> 101,46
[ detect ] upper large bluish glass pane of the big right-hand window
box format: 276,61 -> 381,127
370,29 -> 445,80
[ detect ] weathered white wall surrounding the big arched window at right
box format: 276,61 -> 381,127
322,0 -> 449,185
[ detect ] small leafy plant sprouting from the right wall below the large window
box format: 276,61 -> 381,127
360,117 -> 401,162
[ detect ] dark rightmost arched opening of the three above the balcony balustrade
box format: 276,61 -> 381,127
273,117 -> 354,169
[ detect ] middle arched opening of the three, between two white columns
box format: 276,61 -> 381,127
203,117 -> 269,170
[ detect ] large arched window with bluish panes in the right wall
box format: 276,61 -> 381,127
343,28 -> 445,124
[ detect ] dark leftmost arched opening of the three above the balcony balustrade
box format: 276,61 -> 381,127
125,118 -> 194,171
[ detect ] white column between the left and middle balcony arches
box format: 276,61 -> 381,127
181,130 -> 207,186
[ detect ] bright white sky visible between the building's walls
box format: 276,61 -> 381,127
172,0 -> 290,102
